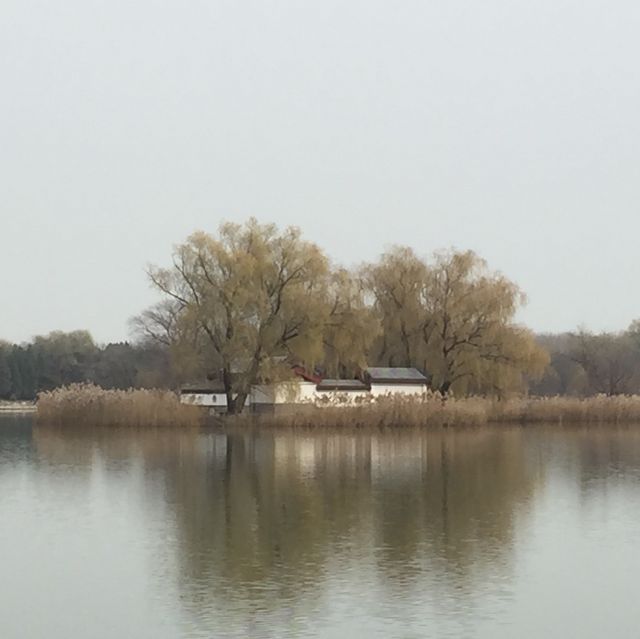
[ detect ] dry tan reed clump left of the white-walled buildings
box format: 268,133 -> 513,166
37,384 -> 204,428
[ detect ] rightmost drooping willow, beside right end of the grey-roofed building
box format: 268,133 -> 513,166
422,251 -> 548,394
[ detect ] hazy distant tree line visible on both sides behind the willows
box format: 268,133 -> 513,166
5,328 -> 640,400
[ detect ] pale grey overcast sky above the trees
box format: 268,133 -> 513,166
0,0 -> 640,341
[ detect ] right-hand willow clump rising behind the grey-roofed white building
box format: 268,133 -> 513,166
364,247 -> 547,394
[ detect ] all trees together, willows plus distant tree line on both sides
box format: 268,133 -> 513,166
6,219 -> 640,428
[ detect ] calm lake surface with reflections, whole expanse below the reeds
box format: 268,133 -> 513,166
0,417 -> 640,639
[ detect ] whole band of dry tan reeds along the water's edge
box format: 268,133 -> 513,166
37,384 -> 640,428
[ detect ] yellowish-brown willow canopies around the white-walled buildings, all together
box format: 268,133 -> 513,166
136,219 -> 547,404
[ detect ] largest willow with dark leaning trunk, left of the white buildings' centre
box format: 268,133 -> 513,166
149,219 -> 329,413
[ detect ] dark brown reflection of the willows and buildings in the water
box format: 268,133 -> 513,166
36,429 -> 535,607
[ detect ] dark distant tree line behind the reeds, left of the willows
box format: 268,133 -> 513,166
0,331 -> 176,400
